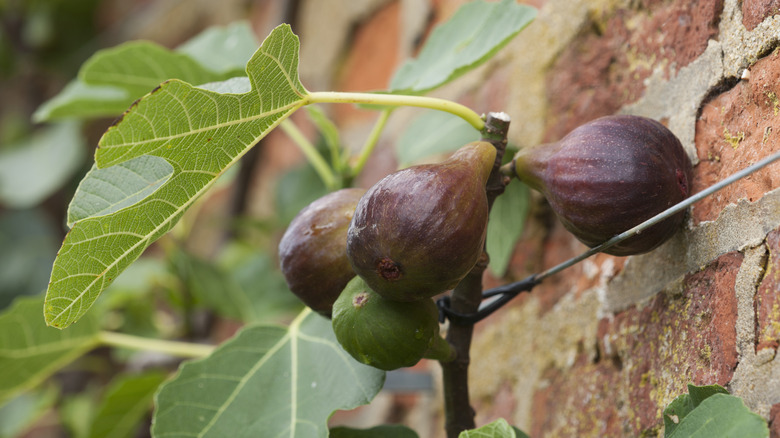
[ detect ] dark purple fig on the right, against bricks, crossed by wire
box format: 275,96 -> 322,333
513,115 -> 692,256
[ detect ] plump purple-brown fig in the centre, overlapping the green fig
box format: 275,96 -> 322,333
347,142 -> 496,301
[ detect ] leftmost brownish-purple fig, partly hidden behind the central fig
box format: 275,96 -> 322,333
279,188 -> 365,317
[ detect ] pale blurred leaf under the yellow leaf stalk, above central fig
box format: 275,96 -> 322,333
396,111 -> 479,167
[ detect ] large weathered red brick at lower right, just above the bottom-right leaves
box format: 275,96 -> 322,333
530,252 -> 743,437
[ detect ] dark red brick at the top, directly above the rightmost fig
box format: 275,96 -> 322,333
545,0 -> 723,141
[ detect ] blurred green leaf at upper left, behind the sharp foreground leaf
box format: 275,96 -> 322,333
33,22 -> 257,122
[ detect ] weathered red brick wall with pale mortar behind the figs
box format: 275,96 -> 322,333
296,0 -> 780,437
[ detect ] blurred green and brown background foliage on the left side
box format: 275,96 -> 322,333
0,0 -> 310,438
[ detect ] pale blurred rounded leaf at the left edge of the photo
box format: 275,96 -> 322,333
0,122 -> 86,208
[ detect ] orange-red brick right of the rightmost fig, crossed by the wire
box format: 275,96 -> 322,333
692,51 -> 780,223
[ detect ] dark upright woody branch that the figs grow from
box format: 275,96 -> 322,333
439,113 -> 510,438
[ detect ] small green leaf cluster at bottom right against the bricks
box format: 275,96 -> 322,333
664,384 -> 769,438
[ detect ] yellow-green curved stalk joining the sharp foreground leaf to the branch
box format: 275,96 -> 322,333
304,91 -> 485,131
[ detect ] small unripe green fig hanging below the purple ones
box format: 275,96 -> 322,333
333,277 -> 454,371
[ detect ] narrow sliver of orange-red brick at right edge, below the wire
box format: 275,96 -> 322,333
756,228 -> 780,351
